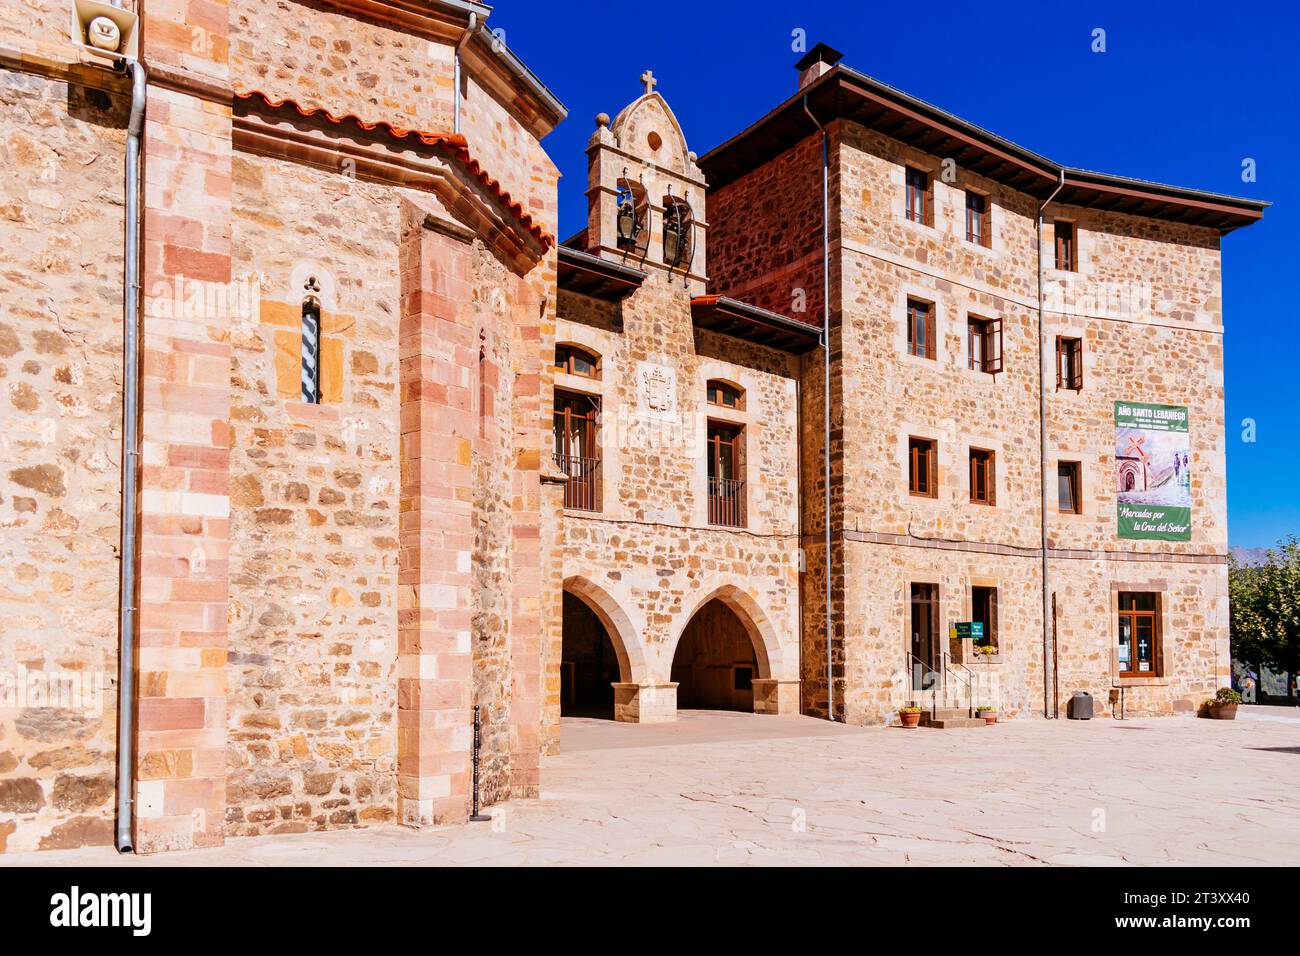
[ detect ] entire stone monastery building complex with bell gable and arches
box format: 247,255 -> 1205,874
0,0 -> 1265,852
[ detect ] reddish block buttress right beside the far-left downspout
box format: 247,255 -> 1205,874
135,13 -> 231,853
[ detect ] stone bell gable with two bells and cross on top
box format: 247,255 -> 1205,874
586,70 -> 709,295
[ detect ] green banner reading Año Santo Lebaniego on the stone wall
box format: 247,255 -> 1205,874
1115,402 -> 1192,541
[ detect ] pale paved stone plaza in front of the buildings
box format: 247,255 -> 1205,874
0,708 -> 1300,866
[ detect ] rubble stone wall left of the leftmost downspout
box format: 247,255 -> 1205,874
0,70 -> 130,852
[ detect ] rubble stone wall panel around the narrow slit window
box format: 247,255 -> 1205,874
226,156 -> 399,835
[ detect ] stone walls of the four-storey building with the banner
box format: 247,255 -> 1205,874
710,111 -> 1227,723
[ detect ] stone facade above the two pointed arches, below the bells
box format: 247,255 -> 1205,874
555,271 -> 800,719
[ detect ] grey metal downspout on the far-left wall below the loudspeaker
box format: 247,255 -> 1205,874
114,60 -> 148,853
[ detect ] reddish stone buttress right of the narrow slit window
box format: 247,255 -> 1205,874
398,206 -> 478,826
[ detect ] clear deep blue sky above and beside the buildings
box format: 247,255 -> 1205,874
489,0 -> 1300,546
